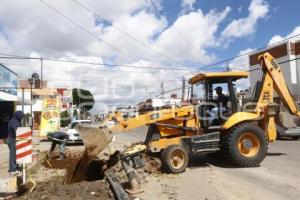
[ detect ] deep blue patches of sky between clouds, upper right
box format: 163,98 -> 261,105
162,0 -> 300,67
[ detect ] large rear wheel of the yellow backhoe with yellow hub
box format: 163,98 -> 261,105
221,123 -> 268,167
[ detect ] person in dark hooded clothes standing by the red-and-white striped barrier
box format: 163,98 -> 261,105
7,111 -> 24,175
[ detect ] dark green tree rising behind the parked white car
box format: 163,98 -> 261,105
72,88 -> 95,113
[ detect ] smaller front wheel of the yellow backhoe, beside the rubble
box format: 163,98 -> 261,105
161,145 -> 189,173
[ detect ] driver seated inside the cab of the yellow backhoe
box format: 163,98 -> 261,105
210,86 -> 228,124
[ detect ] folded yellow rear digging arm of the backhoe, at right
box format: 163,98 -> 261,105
256,53 -> 300,141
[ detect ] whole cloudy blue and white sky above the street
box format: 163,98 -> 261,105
0,0 -> 300,111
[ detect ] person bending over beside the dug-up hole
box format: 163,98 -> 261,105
47,132 -> 69,160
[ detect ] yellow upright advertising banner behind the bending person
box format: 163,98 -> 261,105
40,99 -> 61,137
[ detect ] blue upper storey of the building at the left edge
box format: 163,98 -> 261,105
0,63 -> 18,101
